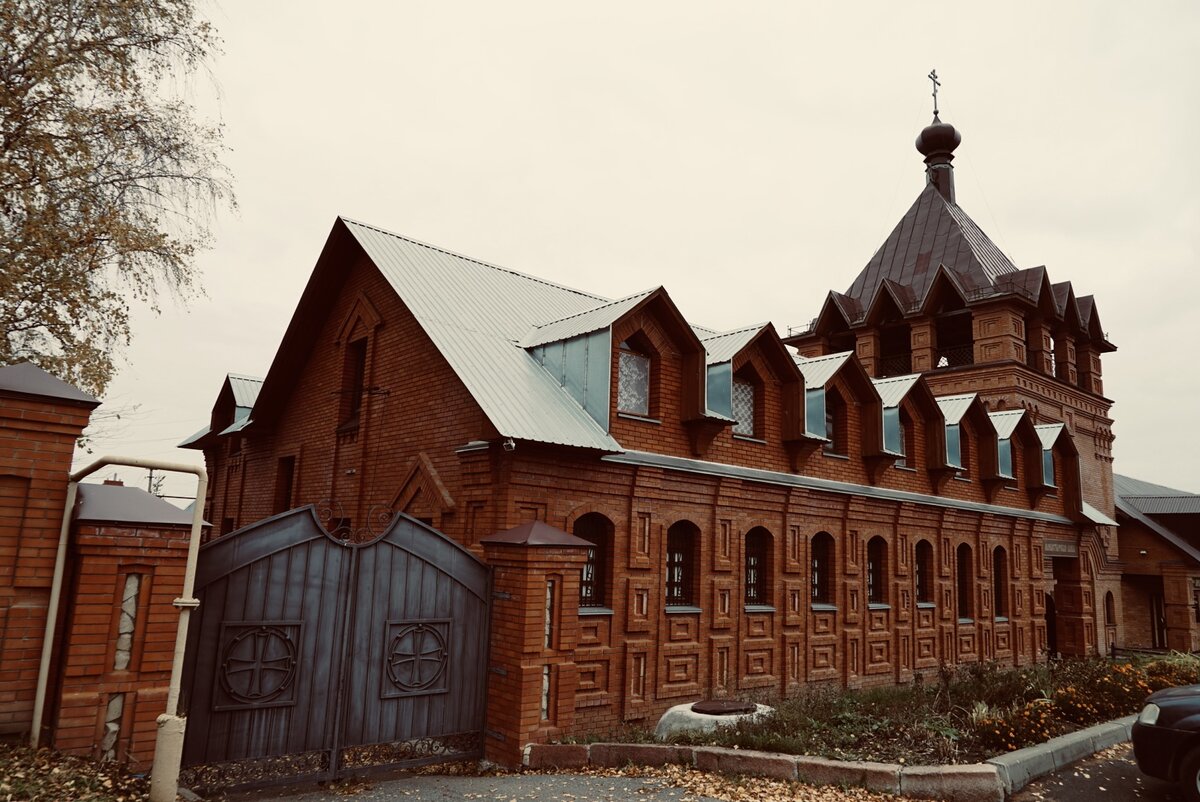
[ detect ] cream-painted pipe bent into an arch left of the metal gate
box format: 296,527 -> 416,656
29,456 -> 209,802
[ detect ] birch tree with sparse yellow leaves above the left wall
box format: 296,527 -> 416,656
0,0 -> 233,395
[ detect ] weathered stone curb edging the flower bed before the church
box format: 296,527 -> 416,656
524,716 -> 1136,802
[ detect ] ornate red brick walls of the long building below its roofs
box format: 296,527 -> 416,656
196,253 -> 1097,753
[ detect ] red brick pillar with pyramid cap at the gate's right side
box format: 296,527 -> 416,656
480,521 -> 592,766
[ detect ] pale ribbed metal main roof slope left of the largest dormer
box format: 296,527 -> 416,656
342,219 -> 620,451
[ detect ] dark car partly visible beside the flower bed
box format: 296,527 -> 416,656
1133,686 -> 1200,802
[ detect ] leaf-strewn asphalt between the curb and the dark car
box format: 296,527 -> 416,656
1013,743 -> 1183,802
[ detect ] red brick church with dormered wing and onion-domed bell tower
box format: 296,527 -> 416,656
177,116 -> 1180,763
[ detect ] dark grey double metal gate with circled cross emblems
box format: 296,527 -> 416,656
181,507 -> 490,789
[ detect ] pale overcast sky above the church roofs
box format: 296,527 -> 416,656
76,0 -> 1200,493
